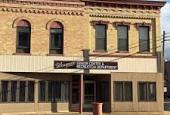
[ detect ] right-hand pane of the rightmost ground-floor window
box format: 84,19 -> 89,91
148,83 -> 156,101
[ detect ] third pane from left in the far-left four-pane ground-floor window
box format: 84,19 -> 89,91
19,81 -> 26,102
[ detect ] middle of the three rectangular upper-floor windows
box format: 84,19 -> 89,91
117,25 -> 129,51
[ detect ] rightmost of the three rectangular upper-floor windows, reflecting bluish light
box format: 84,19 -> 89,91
139,26 -> 150,52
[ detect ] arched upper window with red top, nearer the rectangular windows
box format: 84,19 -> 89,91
50,22 -> 63,54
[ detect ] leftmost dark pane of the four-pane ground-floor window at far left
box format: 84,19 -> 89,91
2,81 -> 8,102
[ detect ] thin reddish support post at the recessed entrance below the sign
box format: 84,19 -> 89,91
79,73 -> 84,113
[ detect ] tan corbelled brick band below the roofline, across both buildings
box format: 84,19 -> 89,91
0,0 -> 160,19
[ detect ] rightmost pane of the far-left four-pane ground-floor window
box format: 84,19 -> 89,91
28,81 -> 34,102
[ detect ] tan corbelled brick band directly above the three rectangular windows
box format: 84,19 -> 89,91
85,7 -> 160,19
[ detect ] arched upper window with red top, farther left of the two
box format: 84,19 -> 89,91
16,20 -> 31,53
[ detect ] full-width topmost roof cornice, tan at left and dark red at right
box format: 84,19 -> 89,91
0,0 -> 165,10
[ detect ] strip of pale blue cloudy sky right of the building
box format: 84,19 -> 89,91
161,0 -> 170,61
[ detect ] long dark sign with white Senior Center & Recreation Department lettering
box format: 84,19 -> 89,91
54,61 -> 118,70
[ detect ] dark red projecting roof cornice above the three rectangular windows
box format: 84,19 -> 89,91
82,0 -> 165,10
